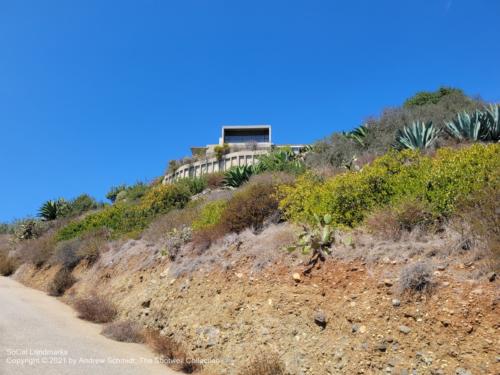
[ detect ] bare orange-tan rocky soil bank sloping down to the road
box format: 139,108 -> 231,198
15,226 -> 500,375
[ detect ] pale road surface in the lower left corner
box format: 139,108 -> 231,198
0,277 -> 177,375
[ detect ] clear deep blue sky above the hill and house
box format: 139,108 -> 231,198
0,0 -> 500,221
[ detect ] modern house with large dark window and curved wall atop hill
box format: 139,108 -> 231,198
163,125 -> 304,183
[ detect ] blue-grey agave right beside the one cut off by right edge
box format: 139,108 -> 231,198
446,111 -> 488,142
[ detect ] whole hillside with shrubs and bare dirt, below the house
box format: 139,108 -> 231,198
0,88 -> 500,375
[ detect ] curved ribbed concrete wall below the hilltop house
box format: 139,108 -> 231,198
163,150 -> 269,184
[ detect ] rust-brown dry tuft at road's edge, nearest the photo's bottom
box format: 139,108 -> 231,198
145,330 -> 202,374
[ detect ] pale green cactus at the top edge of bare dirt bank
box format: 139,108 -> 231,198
287,214 -> 335,274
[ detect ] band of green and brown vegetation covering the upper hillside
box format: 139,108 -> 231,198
0,88 -> 500,276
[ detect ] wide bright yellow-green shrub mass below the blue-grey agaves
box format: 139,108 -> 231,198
280,144 -> 500,227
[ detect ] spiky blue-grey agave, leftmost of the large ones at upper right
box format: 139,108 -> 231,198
393,121 -> 439,150
